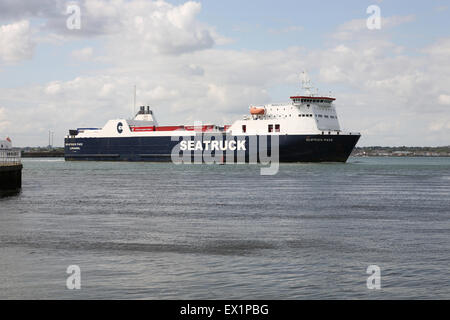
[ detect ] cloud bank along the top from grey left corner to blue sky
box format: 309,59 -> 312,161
0,0 -> 225,54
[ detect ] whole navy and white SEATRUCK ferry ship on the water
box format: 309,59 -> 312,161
65,75 -> 361,163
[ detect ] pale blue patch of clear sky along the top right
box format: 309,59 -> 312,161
200,0 -> 450,50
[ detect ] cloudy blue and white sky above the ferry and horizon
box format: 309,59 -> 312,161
0,0 -> 450,147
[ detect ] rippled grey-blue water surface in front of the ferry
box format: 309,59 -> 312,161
0,158 -> 450,299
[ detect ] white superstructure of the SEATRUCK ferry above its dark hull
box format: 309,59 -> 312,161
68,75 -> 357,138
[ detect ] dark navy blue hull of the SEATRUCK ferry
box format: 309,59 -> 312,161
65,135 -> 360,162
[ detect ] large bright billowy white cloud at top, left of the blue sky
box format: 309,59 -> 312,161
40,0 -> 221,55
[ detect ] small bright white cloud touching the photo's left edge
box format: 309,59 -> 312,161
0,20 -> 34,63
